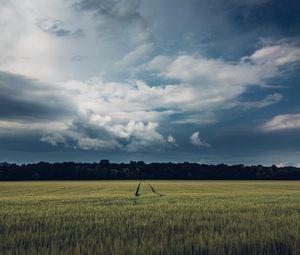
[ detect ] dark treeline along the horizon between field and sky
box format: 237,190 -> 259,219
0,160 -> 300,181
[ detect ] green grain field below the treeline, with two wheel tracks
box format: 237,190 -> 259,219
0,181 -> 300,255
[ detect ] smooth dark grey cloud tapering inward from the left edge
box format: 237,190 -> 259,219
0,72 -> 75,121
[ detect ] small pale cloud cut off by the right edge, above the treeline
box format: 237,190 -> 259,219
263,114 -> 300,131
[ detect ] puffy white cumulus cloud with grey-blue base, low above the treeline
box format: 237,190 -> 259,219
41,112 -> 169,152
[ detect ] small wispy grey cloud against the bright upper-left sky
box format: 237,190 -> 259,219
36,19 -> 84,37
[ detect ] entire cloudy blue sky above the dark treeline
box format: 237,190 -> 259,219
0,0 -> 300,166
